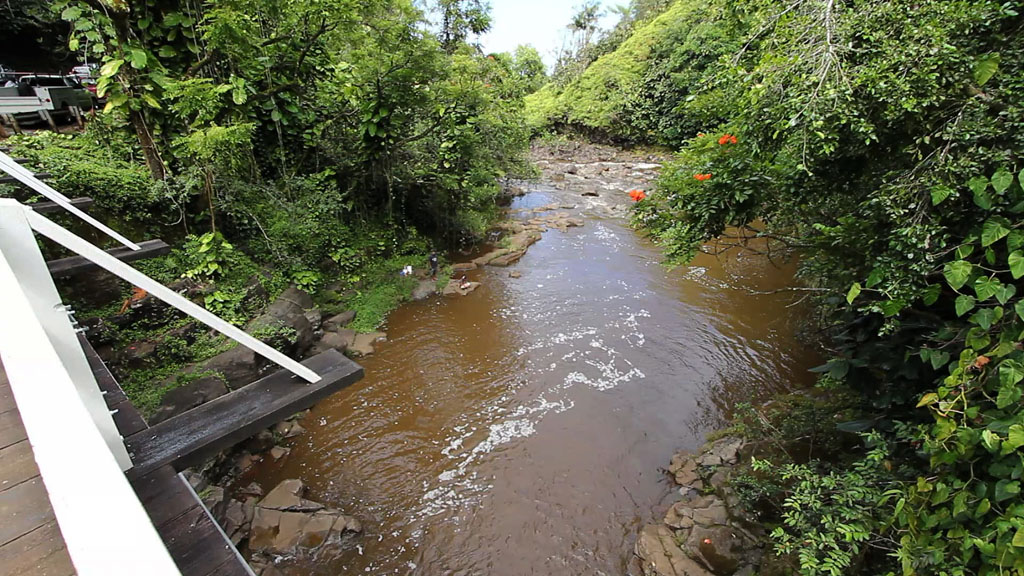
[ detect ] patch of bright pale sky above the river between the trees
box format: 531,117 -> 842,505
479,0 -> 629,70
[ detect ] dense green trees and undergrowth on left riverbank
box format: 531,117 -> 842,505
0,0 -> 546,410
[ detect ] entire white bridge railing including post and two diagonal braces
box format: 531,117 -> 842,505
0,157 -> 321,576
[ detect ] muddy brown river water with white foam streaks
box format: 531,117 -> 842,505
246,147 -> 815,576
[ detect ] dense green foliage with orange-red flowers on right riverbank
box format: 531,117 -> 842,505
529,0 -> 1024,574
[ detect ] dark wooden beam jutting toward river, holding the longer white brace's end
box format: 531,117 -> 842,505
125,349 -> 362,478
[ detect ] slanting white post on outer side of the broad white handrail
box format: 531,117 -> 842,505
0,199 -> 132,470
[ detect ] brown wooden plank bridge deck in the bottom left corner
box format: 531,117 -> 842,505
0,366 -> 75,576
